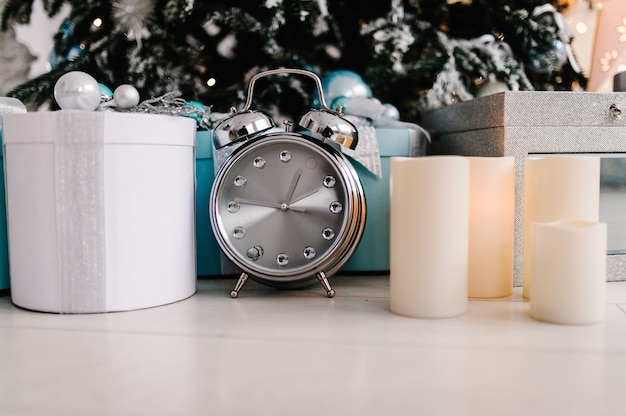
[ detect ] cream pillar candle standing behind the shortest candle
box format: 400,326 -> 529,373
523,155 -> 606,298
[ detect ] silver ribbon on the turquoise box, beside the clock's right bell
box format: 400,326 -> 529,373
341,97 -> 430,178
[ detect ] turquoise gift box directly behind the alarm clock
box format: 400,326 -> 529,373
196,128 -> 426,276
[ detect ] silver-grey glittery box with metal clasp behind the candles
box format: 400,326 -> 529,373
420,91 -> 626,286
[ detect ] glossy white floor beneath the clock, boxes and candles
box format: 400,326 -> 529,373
0,275 -> 626,416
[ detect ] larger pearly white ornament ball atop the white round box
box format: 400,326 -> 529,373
54,71 -> 100,111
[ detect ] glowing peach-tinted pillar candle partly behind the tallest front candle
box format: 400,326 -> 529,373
468,157 -> 515,298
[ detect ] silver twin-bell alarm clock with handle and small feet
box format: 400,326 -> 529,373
209,69 -> 366,297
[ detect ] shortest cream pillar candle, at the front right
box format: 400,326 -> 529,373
530,221 -> 606,324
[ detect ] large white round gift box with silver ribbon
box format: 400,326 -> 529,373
3,110 -> 196,313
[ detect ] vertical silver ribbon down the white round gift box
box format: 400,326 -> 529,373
54,111 -> 106,313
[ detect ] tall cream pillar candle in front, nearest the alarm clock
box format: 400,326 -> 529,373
389,156 -> 469,318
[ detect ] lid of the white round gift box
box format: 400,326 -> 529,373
4,110 -> 196,146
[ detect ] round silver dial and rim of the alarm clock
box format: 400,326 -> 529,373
209,133 -> 365,285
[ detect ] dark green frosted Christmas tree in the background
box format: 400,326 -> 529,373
2,0 -> 586,120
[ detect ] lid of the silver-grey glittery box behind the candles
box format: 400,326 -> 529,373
422,91 -> 626,134
